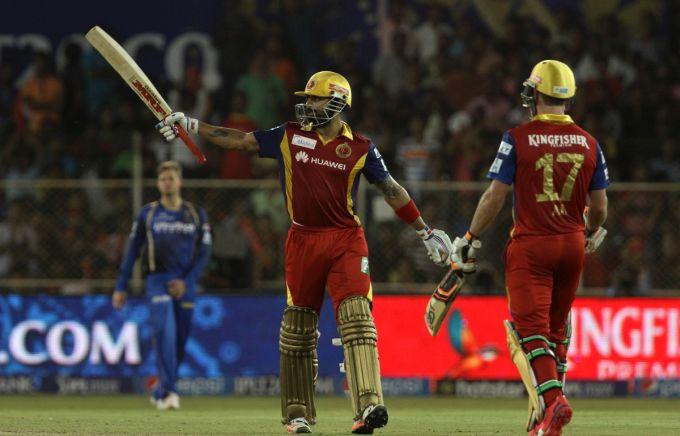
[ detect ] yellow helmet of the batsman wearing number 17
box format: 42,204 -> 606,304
521,59 -> 576,116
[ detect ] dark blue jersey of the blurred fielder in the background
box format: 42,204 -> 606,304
116,201 -> 212,290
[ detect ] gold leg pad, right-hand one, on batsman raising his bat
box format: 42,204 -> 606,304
338,297 -> 383,419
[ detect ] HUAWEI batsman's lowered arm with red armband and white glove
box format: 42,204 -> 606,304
362,144 -> 451,266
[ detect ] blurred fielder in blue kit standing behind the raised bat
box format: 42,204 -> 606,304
111,161 -> 212,410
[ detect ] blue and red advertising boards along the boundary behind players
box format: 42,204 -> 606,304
0,295 -> 680,396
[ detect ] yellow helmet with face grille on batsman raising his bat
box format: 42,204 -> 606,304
295,71 -> 352,127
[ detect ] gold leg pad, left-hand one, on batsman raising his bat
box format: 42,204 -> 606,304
279,306 -> 319,424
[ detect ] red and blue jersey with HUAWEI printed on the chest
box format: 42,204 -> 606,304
254,122 -> 389,227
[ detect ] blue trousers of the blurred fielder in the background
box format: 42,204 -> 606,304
147,277 -> 194,399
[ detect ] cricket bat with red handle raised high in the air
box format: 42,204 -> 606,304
85,26 -> 206,163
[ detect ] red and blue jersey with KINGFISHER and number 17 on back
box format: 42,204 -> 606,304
487,114 -> 609,237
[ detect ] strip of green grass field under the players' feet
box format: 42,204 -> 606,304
0,395 -> 680,436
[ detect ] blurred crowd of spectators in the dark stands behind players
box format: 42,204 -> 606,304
0,1 -> 680,295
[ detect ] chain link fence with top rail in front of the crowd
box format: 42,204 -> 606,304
0,179 -> 680,295
